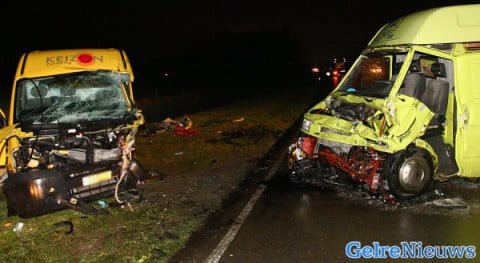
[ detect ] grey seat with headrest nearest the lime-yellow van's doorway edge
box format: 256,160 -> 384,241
421,63 -> 449,124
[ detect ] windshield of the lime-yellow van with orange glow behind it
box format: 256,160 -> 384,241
339,53 -> 405,98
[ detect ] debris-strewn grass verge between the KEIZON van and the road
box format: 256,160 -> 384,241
0,94 -> 312,262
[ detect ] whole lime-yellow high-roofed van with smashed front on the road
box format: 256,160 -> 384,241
289,5 -> 480,199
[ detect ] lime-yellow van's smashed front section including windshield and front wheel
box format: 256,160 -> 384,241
288,51 -> 437,199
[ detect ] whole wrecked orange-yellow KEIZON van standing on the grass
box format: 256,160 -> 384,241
0,49 -> 144,217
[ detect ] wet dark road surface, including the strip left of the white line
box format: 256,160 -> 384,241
171,116 -> 480,262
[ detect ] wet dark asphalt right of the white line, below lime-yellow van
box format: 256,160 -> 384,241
221,169 -> 480,262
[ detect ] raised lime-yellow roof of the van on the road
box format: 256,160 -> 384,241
368,4 -> 480,47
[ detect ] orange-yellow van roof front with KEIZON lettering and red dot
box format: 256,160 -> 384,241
15,48 -> 133,81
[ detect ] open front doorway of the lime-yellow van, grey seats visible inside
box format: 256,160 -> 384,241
398,47 -> 458,175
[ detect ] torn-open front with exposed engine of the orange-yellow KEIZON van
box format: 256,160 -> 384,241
5,126 -> 146,217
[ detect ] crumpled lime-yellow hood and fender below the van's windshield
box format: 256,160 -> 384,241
302,95 -> 434,153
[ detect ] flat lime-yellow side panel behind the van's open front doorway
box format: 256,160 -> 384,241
455,53 -> 480,177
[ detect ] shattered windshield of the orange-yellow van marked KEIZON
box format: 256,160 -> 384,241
15,71 -> 129,124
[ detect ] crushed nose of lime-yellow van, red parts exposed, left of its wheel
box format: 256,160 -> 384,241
289,97 -> 388,192
